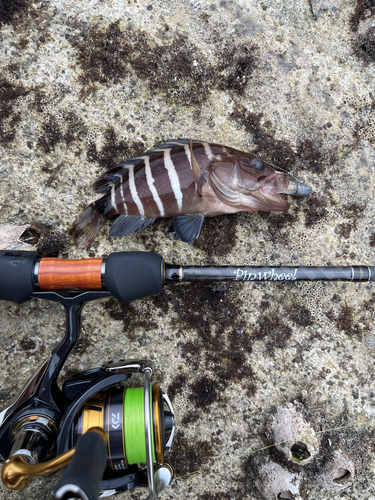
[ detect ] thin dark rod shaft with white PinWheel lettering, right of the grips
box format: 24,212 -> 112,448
165,264 -> 375,282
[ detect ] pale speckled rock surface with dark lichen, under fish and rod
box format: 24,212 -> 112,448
0,0 -> 375,500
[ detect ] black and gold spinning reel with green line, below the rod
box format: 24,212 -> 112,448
0,252 -> 174,500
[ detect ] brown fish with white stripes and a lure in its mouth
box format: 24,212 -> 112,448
71,139 -> 312,247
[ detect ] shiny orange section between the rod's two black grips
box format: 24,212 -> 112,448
38,257 -> 103,290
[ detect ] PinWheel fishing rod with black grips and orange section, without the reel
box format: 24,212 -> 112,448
0,250 -> 375,303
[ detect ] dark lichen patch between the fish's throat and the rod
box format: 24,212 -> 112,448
193,214 -> 241,261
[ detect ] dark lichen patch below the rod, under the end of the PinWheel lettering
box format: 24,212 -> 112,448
251,311 -> 293,354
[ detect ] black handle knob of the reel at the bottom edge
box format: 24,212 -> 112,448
53,427 -> 107,500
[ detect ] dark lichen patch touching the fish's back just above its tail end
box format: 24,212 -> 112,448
86,126 -> 144,169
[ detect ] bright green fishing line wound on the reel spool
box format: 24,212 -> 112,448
124,387 -> 156,465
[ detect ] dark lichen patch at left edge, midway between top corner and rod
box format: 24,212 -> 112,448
0,78 -> 23,146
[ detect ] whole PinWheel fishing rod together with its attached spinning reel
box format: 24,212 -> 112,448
0,250 -> 375,500
